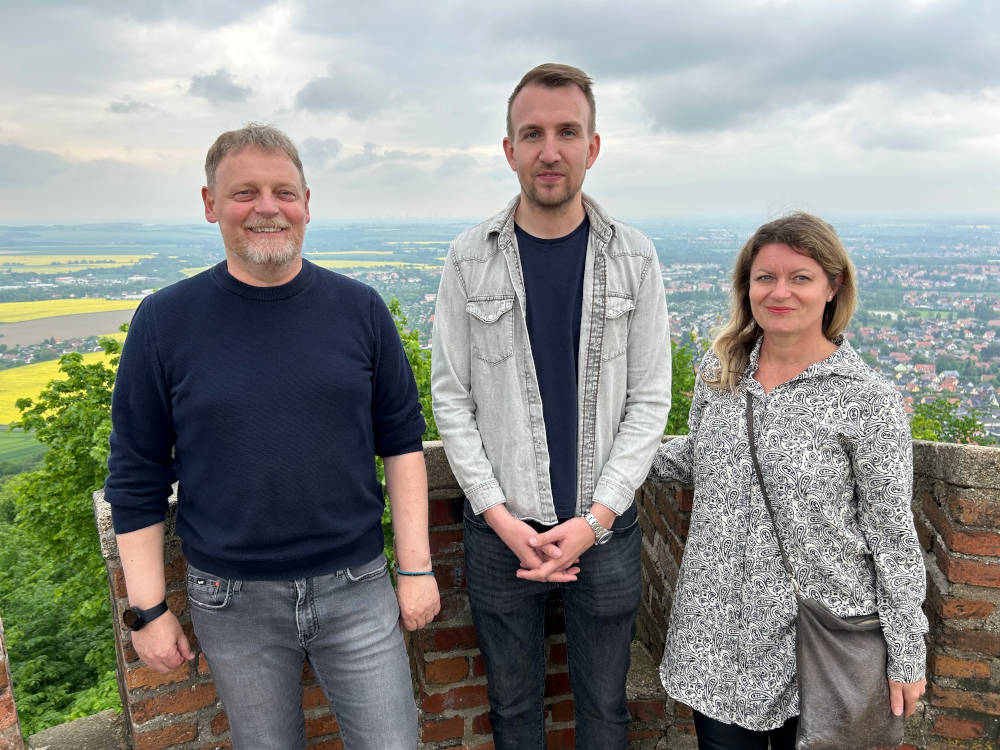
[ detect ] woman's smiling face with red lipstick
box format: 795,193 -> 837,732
749,244 -> 836,344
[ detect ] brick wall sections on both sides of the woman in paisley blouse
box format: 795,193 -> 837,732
638,441 -> 1000,750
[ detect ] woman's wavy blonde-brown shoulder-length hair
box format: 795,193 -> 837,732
702,212 -> 858,390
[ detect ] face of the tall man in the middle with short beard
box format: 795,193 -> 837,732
503,84 -> 601,211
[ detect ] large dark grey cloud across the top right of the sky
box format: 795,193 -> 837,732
292,0 -> 1000,132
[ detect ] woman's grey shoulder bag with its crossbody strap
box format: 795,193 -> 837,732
746,393 -> 903,750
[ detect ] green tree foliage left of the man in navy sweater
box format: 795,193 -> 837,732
0,338 -> 120,734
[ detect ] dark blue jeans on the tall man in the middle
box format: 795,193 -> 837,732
465,502 -> 642,750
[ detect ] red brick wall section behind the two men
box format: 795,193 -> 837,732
92,443 -> 665,750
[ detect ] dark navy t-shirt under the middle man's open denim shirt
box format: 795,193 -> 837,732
514,218 -> 590,520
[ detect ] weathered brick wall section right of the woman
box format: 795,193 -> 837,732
913,441 -> 1000,750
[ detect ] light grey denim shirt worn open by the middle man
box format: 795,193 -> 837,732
431,195 -> 670,524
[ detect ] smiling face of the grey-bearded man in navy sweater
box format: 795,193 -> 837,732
201,146 -> 309,280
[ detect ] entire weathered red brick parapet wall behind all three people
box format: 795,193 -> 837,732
88,442 -> 1000,750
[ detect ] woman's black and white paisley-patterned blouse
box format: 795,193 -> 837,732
650,340 -> 927,730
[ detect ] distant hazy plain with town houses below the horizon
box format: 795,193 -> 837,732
0,219 -> 1000,436
